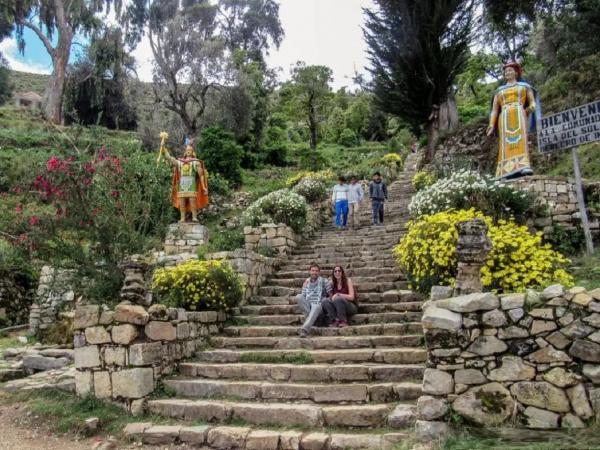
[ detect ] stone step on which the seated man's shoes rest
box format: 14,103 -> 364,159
223,322 -> 423,339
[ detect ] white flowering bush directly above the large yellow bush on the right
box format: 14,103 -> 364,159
408,170 -> 543,223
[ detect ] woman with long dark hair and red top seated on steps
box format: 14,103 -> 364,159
322,266 -> 358,327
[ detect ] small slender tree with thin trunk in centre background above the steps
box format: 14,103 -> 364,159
289,61 -> 333,168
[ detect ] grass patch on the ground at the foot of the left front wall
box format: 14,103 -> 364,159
4,389 -> 168,436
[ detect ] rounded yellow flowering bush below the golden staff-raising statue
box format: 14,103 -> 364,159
152,260 -> 243,311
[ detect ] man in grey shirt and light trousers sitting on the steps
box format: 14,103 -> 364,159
296,263 -> 333,338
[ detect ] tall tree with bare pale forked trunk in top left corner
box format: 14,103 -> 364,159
5,0 -> 121,123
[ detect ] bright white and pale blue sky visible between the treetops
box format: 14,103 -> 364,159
0,0 -> 373,89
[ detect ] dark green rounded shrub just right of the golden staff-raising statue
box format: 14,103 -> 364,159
198,127 -> 243,187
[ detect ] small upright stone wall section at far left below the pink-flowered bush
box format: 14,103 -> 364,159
29,266 -> 75,335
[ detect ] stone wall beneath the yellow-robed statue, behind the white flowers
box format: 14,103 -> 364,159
508,175 -> 600,237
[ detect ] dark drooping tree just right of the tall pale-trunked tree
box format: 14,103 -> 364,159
65,27 -> 136,129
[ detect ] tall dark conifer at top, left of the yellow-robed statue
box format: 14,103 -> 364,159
364,0 -> 474,165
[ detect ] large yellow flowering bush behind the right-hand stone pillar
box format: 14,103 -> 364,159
394,209 -> 573,293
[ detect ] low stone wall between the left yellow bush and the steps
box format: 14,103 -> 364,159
206,249 -> 275,303
